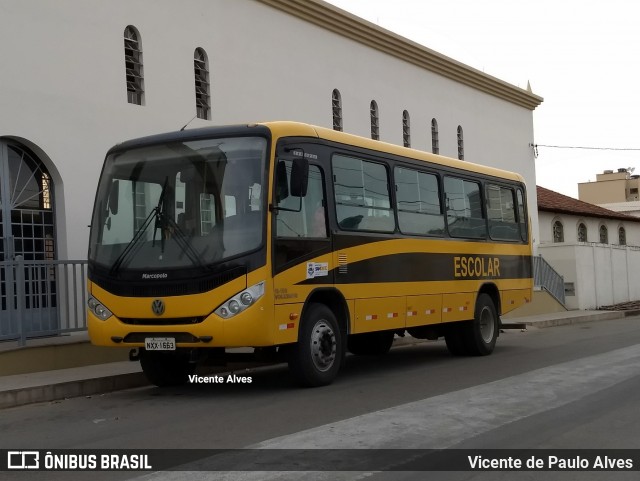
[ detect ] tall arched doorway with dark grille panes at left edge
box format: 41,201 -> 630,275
0,139 -> 58,339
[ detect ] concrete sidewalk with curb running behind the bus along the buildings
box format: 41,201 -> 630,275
0,310 -> 640,409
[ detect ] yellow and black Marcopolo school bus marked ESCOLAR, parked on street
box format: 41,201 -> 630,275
88,122 -> 533,386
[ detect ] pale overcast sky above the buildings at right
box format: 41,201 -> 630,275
327,0 -> 640,198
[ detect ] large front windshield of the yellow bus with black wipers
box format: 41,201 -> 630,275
89,137 -> 267,274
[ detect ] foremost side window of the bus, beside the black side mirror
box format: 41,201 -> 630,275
276,160 -> 327,238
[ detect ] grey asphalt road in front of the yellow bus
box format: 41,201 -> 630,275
0,317 -> 640,480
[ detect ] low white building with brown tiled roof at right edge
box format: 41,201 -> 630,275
537,187 -> 640,309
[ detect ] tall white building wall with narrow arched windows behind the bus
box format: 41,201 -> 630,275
0,0 -> 538,259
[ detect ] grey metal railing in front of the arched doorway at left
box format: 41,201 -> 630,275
0,256 -> 87,346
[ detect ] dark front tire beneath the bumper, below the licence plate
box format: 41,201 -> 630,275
140,349 -> 196,387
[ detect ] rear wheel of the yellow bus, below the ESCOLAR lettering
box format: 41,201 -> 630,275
463,294 -> 500,356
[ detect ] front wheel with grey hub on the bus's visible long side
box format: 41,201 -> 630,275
288,304 -> 344,387
